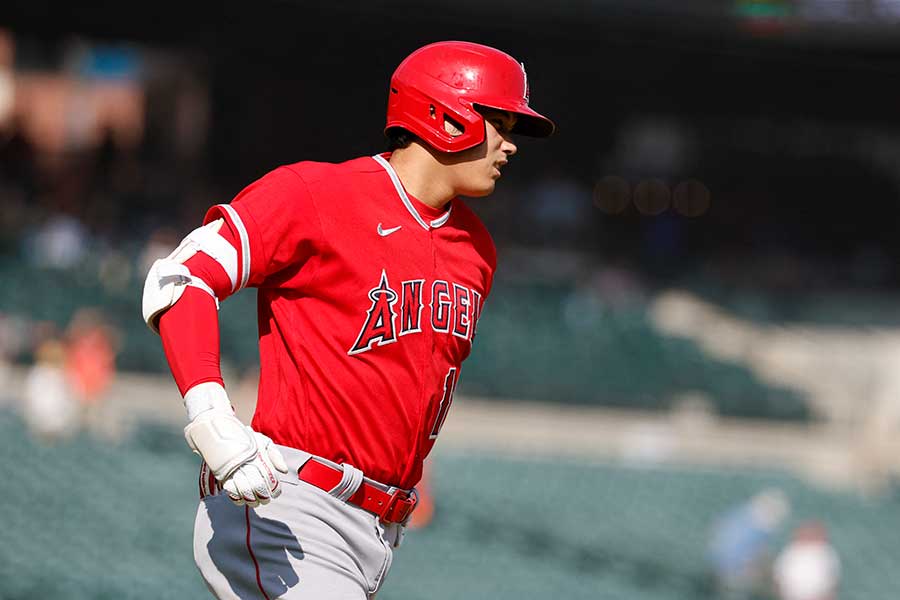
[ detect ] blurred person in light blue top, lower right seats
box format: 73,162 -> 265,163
708,488 -> 790,600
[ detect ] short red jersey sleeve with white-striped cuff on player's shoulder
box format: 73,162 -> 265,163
204,166 -> 322,292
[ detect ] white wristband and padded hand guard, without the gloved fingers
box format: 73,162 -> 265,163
184,382 -> 259,481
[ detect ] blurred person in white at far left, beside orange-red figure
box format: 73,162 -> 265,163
22,337 -> 78,443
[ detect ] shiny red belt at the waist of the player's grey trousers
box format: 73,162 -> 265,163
297,458 -> 418,523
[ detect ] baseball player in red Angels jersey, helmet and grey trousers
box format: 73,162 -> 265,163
143,42 -> 554,600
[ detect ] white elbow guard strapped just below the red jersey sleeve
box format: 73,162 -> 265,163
141,219 -> 237,333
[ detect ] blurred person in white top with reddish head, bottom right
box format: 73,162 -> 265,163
773,521 -> 841,600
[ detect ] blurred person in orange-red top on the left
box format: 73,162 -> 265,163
65,308 -> 118,433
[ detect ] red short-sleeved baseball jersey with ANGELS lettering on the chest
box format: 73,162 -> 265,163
206,154 -> 496,488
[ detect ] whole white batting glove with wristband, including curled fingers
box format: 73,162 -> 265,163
184,382 -> 288,508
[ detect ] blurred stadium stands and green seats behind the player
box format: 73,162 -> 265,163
0,0 -> 900,600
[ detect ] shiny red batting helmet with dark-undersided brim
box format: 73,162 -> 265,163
384,42 -> 556,152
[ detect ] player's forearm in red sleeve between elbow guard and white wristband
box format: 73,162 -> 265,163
159,288 -> 223,395
